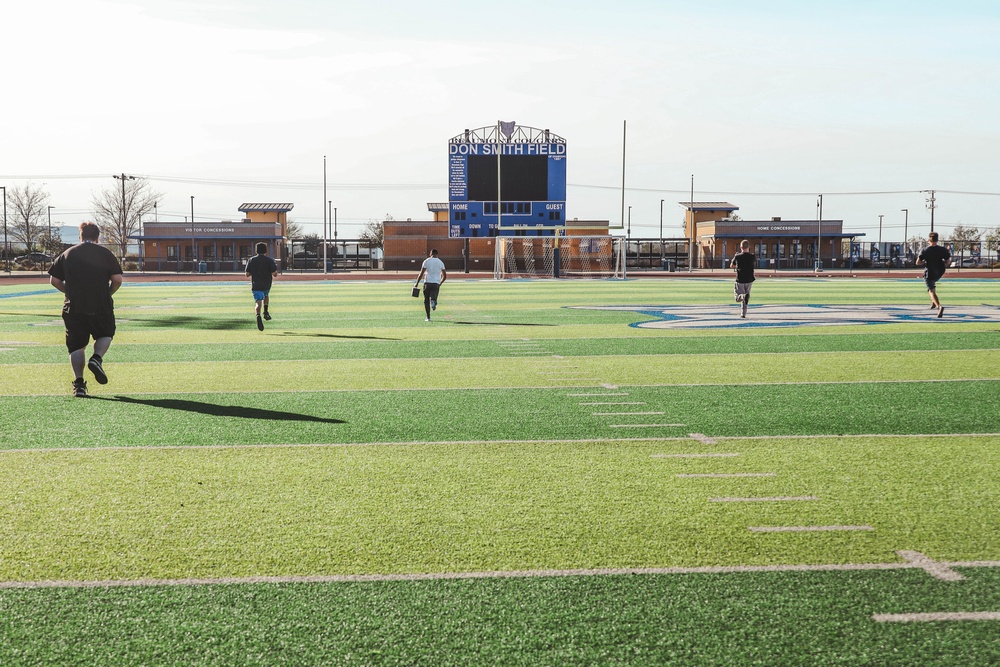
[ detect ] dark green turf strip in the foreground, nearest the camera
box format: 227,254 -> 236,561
0,568 -> 1000,667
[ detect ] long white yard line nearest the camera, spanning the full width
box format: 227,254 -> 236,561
0,560 -> 1000,590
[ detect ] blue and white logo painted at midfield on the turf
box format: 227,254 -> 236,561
569,304 -> 1000,329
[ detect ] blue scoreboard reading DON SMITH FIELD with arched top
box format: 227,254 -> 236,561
448,124 -> 566,238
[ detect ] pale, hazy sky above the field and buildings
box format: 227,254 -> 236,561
0,0 -> 1000,241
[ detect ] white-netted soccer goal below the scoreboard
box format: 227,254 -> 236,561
493,235 -> 625,280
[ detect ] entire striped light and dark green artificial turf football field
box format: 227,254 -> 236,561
0,272 -> 1000,665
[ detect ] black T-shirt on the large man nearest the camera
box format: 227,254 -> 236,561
49,241 -> 122,315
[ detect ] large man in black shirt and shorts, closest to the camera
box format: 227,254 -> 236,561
49,222 -> 122,398
